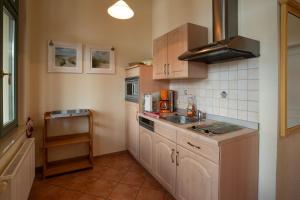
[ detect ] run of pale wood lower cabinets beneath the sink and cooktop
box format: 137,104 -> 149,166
140,115 -> 258,200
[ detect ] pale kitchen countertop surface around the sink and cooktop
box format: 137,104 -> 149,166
139,113 -> 258,146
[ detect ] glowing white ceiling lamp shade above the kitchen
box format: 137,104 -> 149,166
107,0 -> 134,19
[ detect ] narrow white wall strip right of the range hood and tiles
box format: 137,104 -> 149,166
239,0 -> 279,200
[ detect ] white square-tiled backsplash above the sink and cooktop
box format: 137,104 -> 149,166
170,58 -> 259,122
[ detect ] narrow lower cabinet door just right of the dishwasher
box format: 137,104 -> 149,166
154,134 -> 176,195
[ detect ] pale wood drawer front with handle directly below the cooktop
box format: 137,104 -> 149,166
177,131 -> 219,163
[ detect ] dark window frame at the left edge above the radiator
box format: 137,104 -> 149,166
0,0 -> 19,138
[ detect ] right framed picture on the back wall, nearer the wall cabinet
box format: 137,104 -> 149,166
85,45 -> 116,74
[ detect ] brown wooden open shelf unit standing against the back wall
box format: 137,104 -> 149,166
43,110 -> 93,177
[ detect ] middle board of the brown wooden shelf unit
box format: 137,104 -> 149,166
45,133 -> 91,148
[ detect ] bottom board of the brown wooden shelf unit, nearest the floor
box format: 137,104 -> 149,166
44,156 -> 93,176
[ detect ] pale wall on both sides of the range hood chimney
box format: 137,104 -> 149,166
152,0 -> 279,200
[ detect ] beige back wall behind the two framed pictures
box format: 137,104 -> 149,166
27,0 -> 152,166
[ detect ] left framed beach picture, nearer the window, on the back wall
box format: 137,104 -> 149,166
48,40 -> 82,73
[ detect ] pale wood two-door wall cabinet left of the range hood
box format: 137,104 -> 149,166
153,23 -> 208,79
